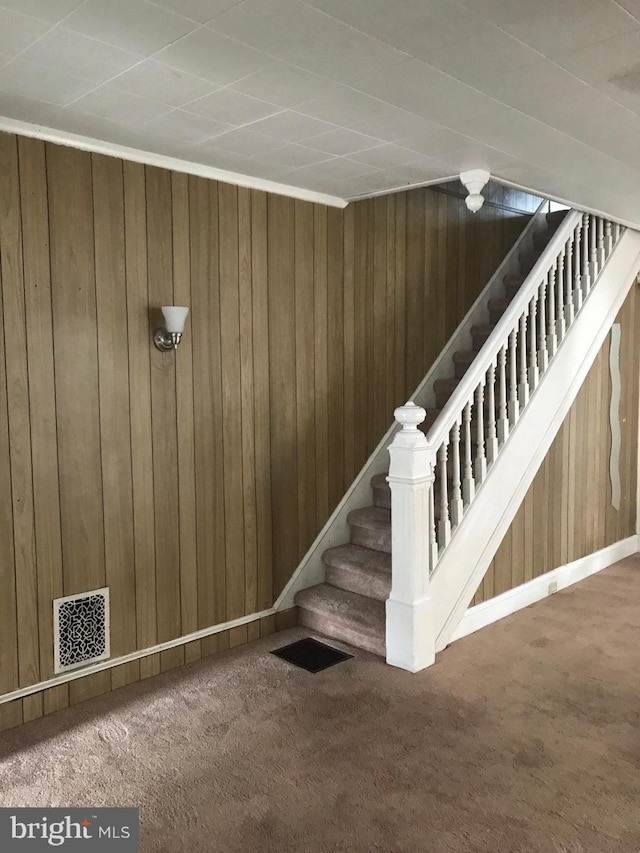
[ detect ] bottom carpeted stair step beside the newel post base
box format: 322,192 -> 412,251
295,583 -> 386,657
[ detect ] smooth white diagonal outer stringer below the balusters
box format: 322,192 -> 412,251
430,229 -> 640,651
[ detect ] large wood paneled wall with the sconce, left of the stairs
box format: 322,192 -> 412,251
0,134 -> 536,727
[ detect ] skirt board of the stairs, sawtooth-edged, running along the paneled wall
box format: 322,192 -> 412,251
274,196 -> 549,610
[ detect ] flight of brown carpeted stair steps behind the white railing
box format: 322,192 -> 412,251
295,210 -> 566,657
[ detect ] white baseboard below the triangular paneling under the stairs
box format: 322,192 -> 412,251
451,535 -> 640,642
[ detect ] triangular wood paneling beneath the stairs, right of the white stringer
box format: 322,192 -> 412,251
473,284 -> 640,604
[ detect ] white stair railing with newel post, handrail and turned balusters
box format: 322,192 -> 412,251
387,211 -> 622,672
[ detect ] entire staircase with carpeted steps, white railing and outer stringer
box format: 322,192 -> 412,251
286,205 -> 640,672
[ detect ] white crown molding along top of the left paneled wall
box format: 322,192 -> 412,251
0,116 -> 349,208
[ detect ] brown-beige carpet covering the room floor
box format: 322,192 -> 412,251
0,558 -> 640,853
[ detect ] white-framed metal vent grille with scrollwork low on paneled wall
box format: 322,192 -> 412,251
53,587 -> 110,672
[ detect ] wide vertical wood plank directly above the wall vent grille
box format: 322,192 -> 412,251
46,145 -> 106,596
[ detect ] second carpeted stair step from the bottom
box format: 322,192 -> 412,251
322,544 -> 391,601
